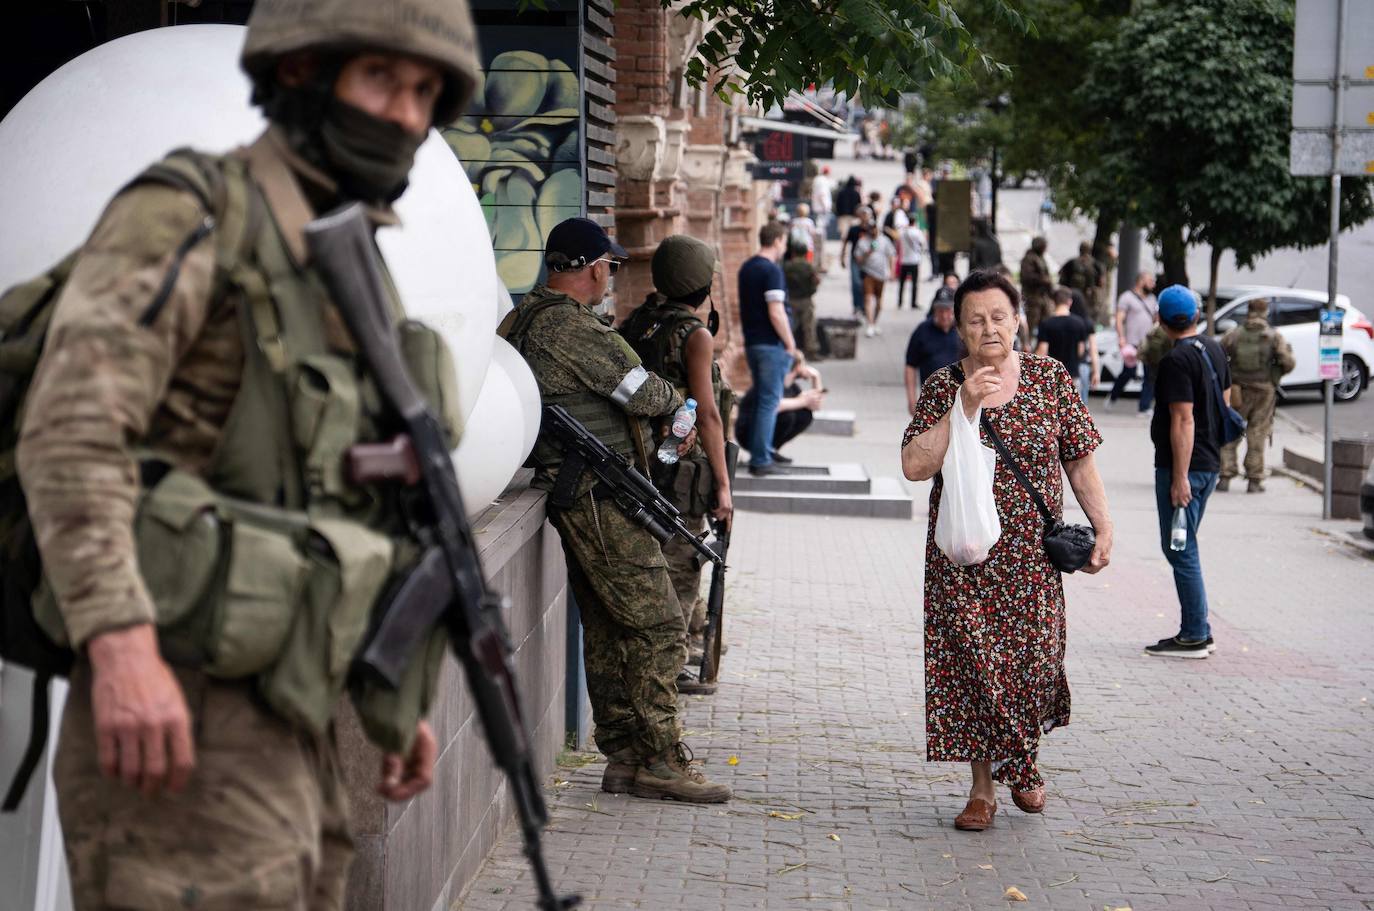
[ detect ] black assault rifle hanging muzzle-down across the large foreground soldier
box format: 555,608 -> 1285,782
305,203 -> 580,911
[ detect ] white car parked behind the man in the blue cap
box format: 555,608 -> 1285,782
1094,284 -> 1374,401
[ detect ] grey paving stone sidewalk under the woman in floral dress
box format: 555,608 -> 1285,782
455,254 -> 1374,911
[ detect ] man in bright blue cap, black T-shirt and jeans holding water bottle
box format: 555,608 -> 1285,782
1146,284 -> 1231,658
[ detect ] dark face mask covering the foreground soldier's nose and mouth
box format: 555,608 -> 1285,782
320,96 -> 425,202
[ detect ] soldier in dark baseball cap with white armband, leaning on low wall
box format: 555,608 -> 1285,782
497,218 -> 730,804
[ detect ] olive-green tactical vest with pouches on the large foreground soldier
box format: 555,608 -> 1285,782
22,148 -> 456,752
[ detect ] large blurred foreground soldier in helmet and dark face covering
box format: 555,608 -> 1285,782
18,0 -> 478,911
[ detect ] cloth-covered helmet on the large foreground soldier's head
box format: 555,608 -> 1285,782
239,0 -> 478,124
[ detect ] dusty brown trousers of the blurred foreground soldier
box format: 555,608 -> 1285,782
52,664 -> 353,911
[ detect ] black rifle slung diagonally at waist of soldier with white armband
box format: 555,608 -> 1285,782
543,405 -> 725,566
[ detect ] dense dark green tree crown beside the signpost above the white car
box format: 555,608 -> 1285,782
1074,0 -> 1374,280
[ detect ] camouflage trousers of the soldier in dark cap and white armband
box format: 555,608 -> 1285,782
550,493 -> 687,756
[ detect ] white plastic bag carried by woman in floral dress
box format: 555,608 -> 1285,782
936,389 -> 1002,566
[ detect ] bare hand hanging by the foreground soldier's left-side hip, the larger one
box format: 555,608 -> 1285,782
87,624 -> 195,797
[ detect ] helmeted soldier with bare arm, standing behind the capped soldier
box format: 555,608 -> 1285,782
620,234 -> 736,694
